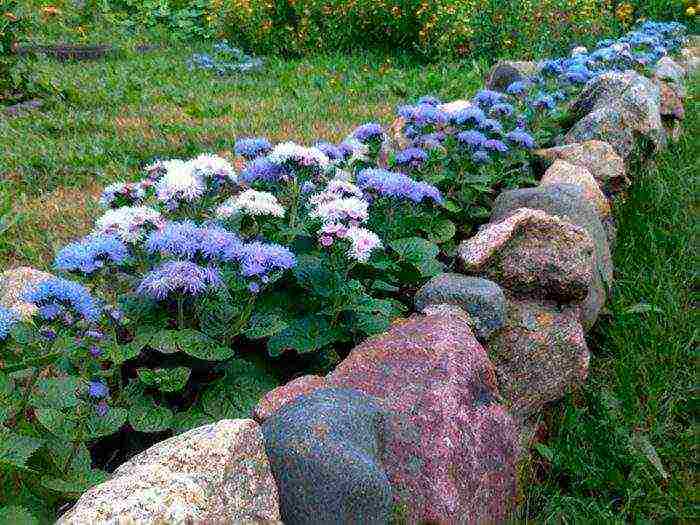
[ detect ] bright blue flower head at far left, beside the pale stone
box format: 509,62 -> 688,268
24,277 -> 102,321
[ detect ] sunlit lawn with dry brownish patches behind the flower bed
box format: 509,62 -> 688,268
0,47 -> 485,268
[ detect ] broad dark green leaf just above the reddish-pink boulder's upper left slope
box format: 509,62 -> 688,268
267,315 -> 340,357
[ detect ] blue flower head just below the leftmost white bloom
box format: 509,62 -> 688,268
54,234 -> 129,274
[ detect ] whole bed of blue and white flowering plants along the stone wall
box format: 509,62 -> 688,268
3,7 -> 696,524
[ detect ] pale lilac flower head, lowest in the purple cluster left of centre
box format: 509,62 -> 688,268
137,261 -> 223,301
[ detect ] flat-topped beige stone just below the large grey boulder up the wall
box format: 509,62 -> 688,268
534,140 -> 630,195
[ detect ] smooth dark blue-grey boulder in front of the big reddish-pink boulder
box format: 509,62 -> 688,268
262,388 -> 392,525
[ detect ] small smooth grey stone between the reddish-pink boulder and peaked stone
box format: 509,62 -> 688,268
415,273 -> 506,340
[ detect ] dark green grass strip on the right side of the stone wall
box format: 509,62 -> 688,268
527,78 -> 700,523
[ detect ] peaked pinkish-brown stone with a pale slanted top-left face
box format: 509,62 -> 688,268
457,208 -> 595,302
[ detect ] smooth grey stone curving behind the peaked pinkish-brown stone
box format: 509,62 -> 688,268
491,184 -> 613,330
